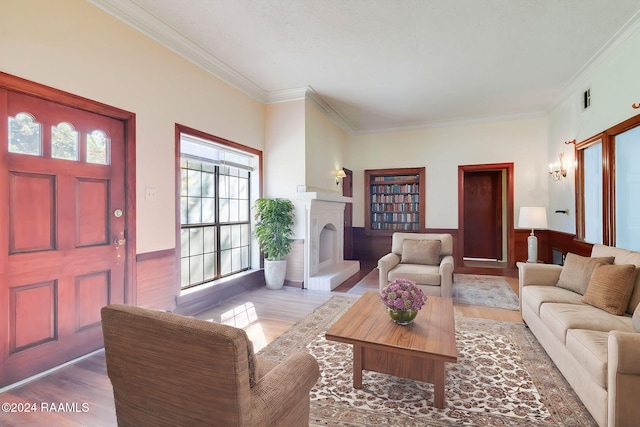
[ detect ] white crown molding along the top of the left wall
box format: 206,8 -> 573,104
87,0 -> 269,103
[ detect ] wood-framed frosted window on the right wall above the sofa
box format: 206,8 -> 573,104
576,116 -> 640,250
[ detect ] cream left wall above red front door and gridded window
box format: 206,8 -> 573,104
0,0 -> 264,253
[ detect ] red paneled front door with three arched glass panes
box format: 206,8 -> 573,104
0,89 -> 127,386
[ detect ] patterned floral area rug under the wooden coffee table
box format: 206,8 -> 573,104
258,296 -> 597,427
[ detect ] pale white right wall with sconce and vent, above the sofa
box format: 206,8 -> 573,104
547,25 -> 640,234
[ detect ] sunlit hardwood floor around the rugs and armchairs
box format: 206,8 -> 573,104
0,264 -> 522,427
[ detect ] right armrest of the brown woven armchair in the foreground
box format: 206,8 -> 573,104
251,352 -> 320,426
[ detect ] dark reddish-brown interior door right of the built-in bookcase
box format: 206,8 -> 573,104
463,170 -> 503,260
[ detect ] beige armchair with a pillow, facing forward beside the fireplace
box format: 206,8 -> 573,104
378,233 -> 454,298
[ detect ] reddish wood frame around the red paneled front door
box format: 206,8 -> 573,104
0,72 -> 137,305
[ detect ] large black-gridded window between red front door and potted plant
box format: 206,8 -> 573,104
180,133 -> 254,289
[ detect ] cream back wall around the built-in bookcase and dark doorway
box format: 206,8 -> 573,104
351,117 -> 548,228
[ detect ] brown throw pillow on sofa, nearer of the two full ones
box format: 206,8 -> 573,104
582,264 -> 637,316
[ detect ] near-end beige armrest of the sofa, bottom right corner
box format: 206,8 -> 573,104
607,331 -> 640,426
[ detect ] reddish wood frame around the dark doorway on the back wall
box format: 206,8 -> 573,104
455,163 -> 515,268
